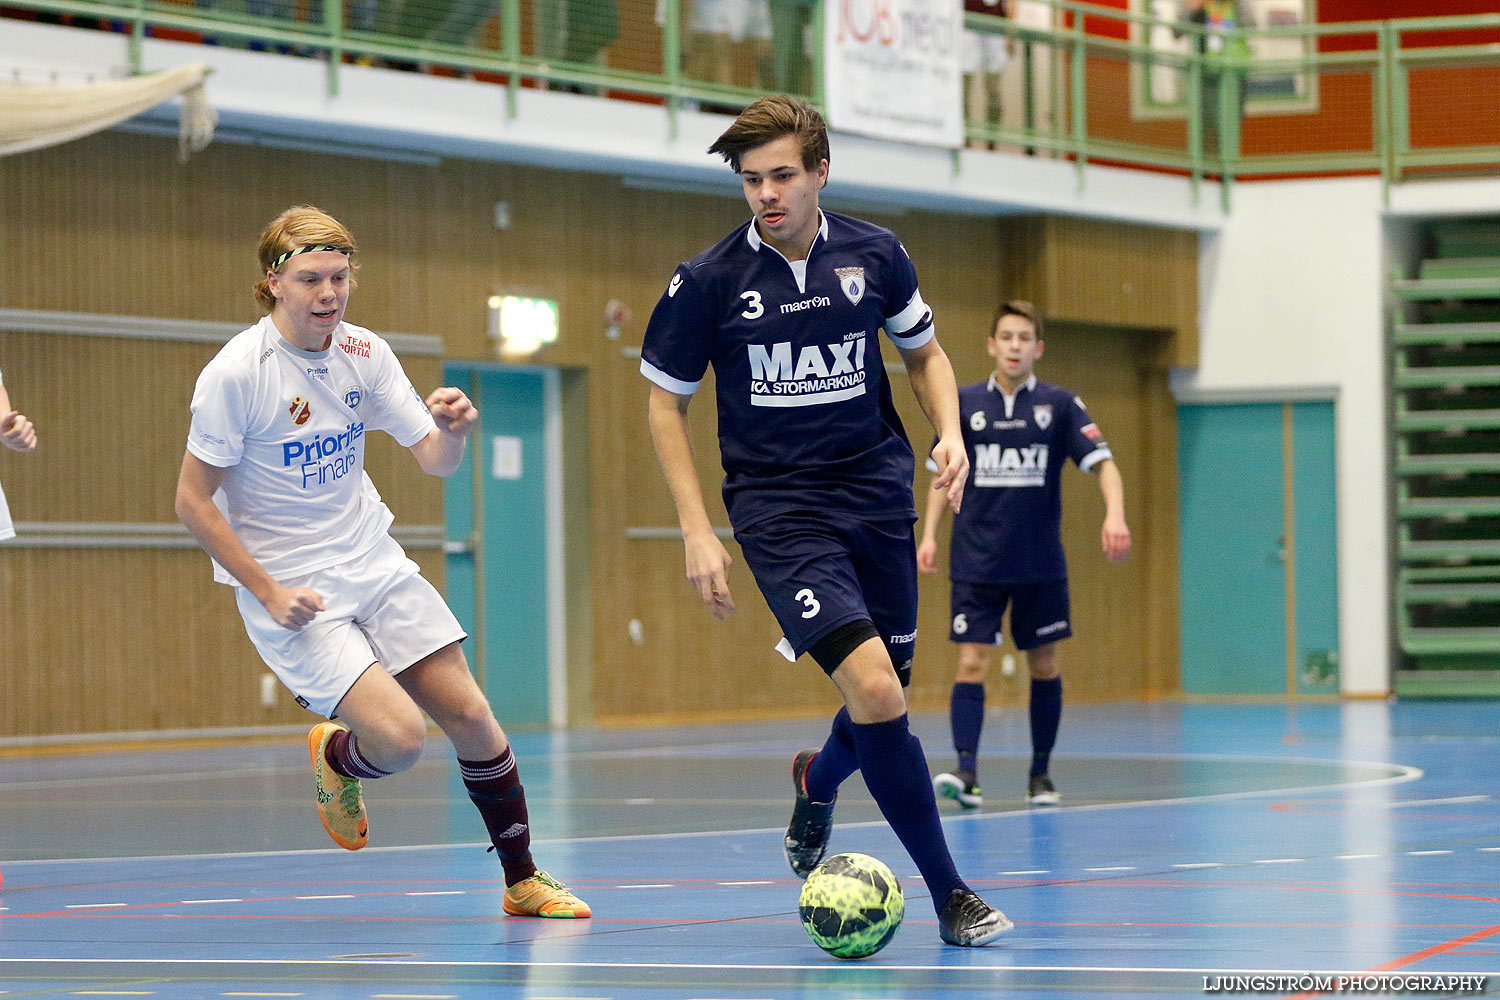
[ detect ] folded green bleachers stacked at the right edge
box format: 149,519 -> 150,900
1391,217 -> 1500,697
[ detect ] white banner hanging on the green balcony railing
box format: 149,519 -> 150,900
824,0 -> 963,147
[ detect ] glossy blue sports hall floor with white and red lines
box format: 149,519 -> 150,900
0,702 -> 1500,1000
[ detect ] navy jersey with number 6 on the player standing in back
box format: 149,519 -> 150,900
929,375 -> 1113,583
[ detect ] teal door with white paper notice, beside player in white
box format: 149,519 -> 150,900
444,364 -> 566,729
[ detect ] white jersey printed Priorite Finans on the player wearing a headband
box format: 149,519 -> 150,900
188,316 -> 435,583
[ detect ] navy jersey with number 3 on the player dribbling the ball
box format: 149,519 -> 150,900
641,213 -> 933,529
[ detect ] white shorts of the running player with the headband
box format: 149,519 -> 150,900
234,535 -> 467,718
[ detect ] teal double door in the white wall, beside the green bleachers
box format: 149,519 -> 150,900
1178,402 -> 1338,694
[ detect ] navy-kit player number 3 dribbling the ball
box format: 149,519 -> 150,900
641,94 -> 1011,945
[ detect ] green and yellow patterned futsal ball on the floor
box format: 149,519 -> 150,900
798,855 -> 906,958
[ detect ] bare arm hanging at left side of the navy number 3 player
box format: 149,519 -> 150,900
647,385 -> 735,621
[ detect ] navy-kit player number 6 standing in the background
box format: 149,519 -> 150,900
917,300 -> 1130,808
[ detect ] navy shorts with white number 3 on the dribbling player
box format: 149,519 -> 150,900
735,514 -> 917,681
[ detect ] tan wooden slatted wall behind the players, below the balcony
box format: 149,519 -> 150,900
0,133 -> 1196,736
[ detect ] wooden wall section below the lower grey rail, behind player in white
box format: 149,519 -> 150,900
0,547 -> 441,736
